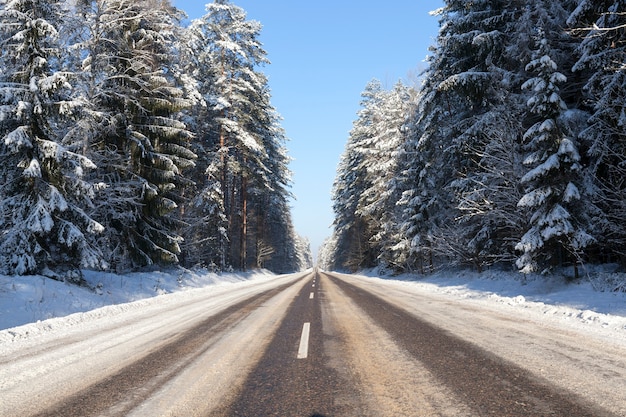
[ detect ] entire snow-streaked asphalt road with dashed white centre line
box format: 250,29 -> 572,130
0,272 -> 626,417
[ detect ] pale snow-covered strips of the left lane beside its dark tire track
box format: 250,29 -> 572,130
0,275 -> 302,417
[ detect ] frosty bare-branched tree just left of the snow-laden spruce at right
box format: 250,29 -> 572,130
449,106 -> 526,271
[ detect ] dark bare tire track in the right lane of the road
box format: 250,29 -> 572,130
324,274 -> 617,417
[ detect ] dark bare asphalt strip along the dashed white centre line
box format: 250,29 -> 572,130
211,274 -> 364,417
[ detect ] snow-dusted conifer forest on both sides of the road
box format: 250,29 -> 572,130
0,0 -> 626,279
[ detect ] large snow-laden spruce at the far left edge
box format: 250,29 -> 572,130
0,0 -> 105,281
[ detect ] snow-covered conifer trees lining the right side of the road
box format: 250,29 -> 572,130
321,0 -> 626,275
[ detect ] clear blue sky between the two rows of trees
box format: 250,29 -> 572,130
173,0 -> 443,253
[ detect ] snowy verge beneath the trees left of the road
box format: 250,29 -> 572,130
0,269 -> 275,334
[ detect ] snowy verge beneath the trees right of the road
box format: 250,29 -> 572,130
363,265 -> 626,346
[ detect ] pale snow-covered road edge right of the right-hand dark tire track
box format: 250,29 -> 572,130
326,275 -> 626,416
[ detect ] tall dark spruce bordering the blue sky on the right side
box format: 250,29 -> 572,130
399,0 -> 516,269
